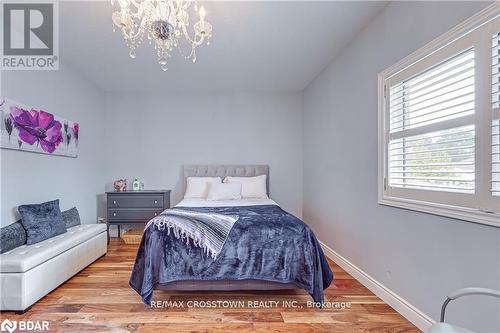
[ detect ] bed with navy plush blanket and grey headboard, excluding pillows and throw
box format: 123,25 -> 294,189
129,165 -> 333,304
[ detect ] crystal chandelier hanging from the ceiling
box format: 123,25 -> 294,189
111,0 -> 212,71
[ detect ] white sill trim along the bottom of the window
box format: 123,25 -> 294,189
378,196 -> 500,228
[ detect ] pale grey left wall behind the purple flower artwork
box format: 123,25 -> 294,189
0,63 -> 104,226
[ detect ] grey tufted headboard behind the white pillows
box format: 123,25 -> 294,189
182,164 -> 269,195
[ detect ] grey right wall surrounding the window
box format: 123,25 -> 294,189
304,2 -> 500,332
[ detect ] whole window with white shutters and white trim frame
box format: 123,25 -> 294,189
379,3 -> 500,226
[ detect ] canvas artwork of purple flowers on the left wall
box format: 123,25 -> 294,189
0,97 -> 80,157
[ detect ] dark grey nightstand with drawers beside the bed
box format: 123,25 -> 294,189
106,190 -> 170,242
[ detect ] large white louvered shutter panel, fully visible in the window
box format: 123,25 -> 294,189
388,49 -> 475,193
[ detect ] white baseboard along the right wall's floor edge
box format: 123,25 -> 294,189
319,241 -> 435,332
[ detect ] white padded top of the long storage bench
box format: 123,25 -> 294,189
0,224 -> 106,273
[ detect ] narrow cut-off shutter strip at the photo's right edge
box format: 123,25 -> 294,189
491,33 -> 500,196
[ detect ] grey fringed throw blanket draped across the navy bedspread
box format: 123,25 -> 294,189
145,209 -> 238,259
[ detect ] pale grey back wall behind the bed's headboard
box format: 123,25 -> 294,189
105,92 -> 302,216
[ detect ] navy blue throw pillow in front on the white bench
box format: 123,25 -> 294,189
17,200 -> 66,245
